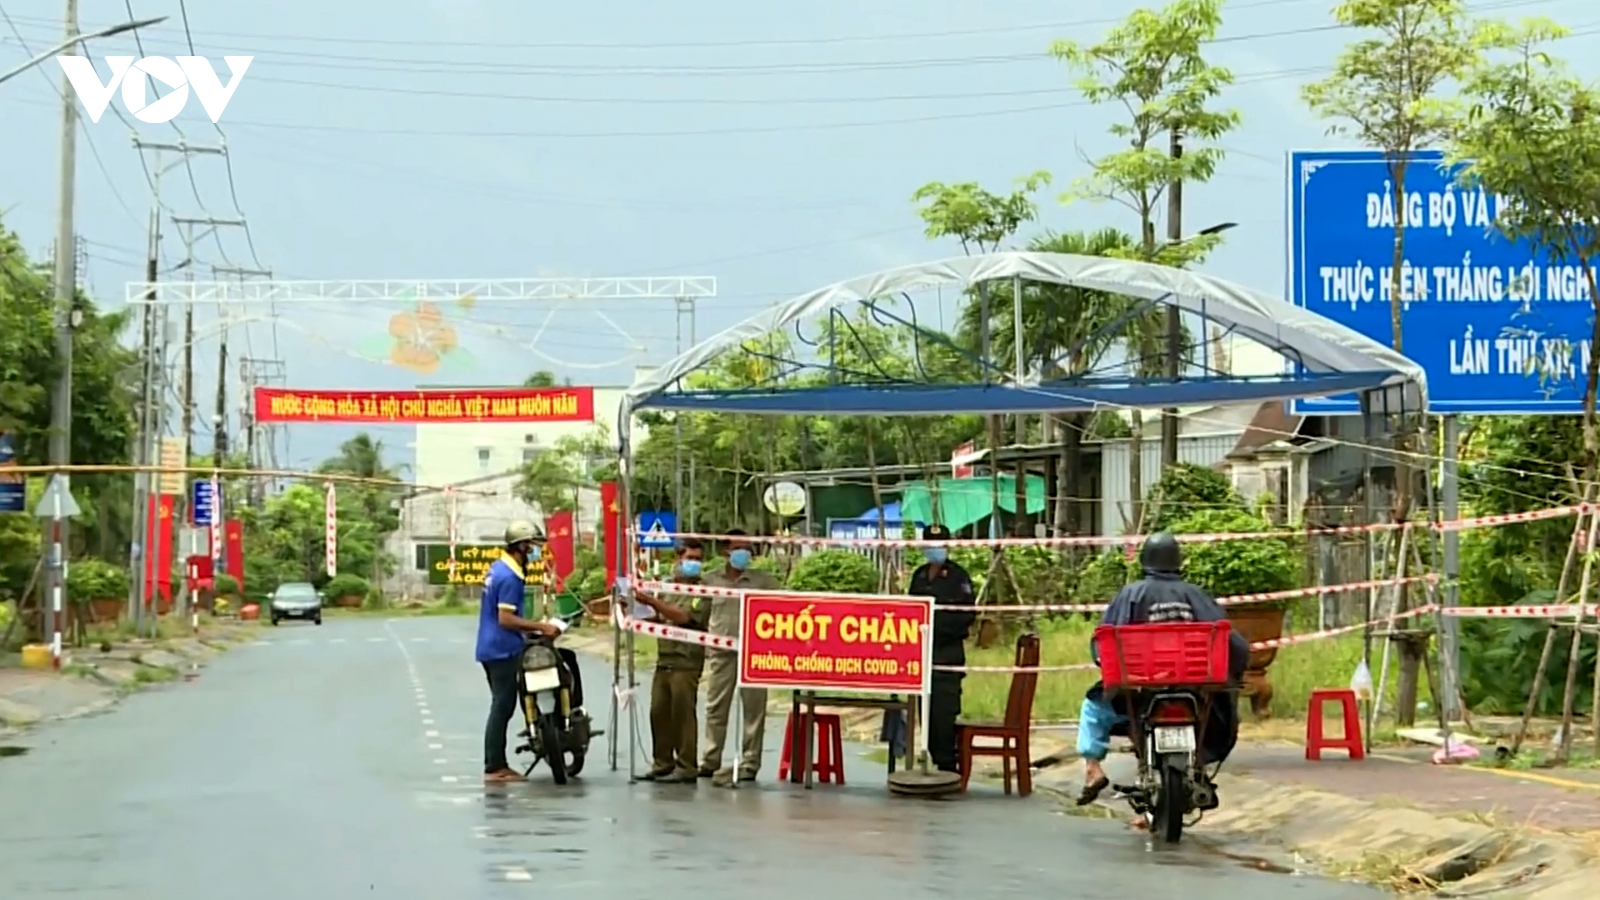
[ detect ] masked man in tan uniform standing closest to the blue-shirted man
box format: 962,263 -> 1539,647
638,538 -> 710,785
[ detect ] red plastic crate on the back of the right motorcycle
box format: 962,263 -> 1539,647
1094,621 -> 1234,687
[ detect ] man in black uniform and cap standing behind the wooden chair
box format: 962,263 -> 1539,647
910,525 -> 978,772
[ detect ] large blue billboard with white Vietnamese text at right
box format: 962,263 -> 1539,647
1288,151 -> 1594,415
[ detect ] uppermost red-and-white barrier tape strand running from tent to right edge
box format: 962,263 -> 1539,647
643,504 -> 1590,548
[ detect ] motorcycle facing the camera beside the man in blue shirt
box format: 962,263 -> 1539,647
517,637 -> 605,785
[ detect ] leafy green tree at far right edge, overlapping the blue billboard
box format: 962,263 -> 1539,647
1451,21 -> 1600,759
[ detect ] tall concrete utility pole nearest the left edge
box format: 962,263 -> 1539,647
40,0 -> 80,643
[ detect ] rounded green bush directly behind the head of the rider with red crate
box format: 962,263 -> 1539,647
1171,509 -> 1301,597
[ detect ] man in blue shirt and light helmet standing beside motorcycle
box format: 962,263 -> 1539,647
477,520 -> 562,781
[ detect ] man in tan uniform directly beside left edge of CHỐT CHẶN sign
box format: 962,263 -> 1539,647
699,528 -> 782,786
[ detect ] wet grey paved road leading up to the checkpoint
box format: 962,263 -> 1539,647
0,618 -> 1376,900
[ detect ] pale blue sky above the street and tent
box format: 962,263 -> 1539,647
0,0 -> 1600,477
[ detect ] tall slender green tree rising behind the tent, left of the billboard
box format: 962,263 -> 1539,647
1050,0 -> 1240,528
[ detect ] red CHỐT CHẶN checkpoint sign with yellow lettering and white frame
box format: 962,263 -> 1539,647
739,593 -> 933,693
